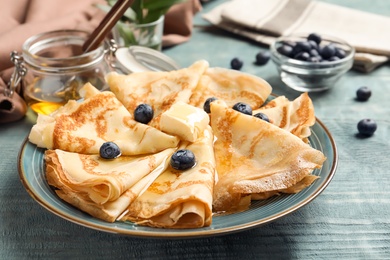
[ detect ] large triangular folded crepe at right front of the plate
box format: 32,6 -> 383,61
210,102 -> 326,211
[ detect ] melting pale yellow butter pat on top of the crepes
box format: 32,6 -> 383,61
160,101 -> 210,142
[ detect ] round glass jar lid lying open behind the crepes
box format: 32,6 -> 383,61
115,46 -> 180,73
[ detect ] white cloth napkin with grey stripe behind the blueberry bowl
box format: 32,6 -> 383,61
203,0 -> 390,72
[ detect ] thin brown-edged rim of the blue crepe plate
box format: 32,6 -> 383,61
18,117 -> 338,238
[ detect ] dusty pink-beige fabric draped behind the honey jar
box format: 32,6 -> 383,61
0,0 -> 105,124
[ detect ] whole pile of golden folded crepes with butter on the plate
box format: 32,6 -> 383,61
29,61 -> 326,228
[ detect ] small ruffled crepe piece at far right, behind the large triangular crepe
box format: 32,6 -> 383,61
253,93 -> 316,142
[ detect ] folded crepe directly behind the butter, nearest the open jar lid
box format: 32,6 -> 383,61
106,60 -> 209,126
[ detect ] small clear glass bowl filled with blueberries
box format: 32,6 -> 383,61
270,33 -> 355,92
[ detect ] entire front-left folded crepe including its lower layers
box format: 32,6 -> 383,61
45,148 -> 174,222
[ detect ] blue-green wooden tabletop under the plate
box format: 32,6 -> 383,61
0,0 -> 390,259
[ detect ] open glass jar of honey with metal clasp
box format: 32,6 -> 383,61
22,30 -> 113,114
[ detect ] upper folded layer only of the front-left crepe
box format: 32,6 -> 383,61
45,148 -> 174,204
